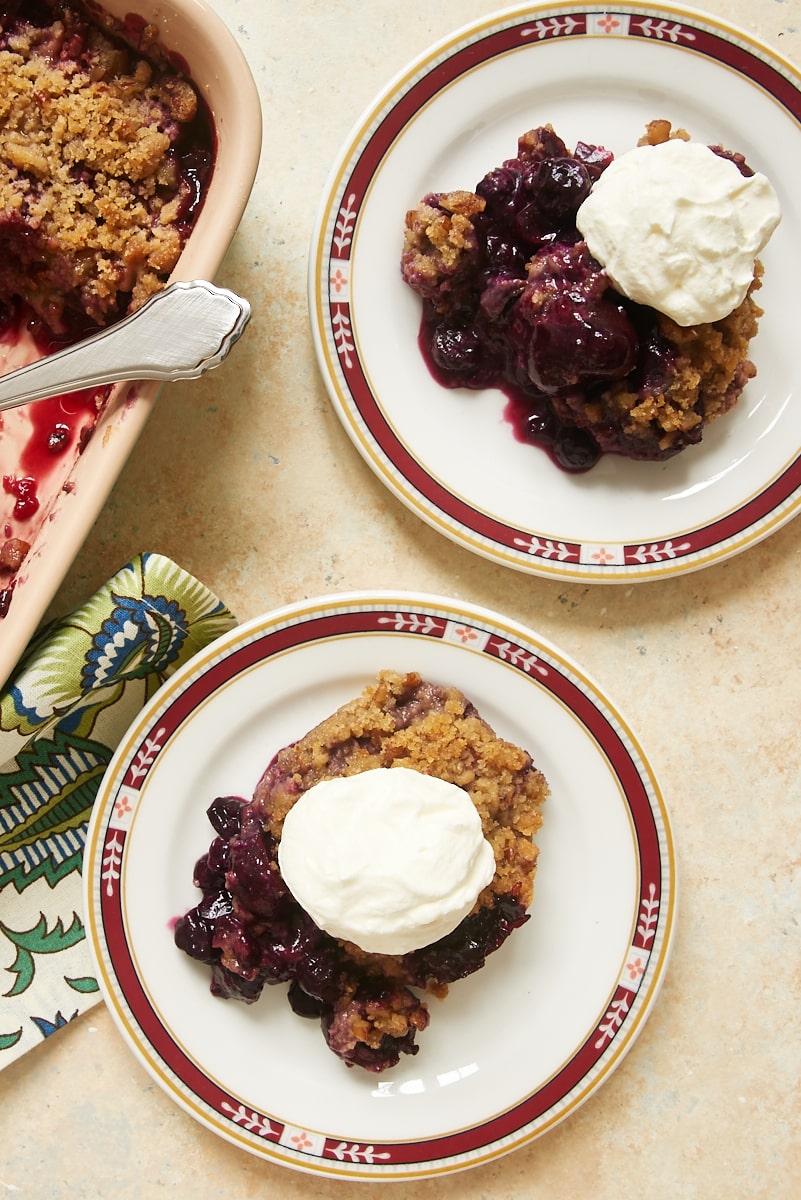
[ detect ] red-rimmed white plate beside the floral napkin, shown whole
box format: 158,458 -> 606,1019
84,592 -> 676,1180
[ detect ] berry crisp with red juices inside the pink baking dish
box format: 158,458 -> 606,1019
0,0 -> 213,616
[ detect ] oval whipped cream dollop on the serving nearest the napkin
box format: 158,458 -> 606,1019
278,767 -> 495,954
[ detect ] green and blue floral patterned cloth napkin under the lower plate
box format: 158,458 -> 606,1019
0,554 -> 236,1068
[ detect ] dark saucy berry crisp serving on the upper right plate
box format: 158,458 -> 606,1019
401,120 -> 778,472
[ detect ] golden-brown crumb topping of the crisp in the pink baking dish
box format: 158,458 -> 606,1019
0,2 -> 198,331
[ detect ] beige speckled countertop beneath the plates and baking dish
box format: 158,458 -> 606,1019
0,0 -> 801,1200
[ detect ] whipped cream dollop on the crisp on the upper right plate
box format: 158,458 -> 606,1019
576,138 -> 781,325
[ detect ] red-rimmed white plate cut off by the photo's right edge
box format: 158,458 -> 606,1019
308,0 -> 801,583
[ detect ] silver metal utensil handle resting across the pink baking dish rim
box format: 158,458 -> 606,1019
0,280 -> 251,412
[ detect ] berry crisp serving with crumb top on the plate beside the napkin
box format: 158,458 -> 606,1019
174,671 -> 548,1072
